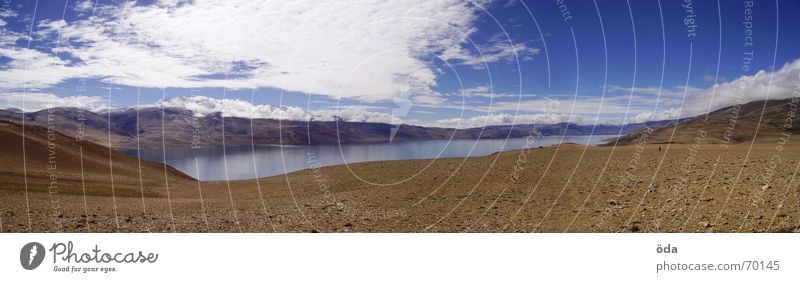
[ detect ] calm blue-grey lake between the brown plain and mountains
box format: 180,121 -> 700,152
121,135 -> 616,180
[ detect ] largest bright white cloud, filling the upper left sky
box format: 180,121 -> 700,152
0,0 -> 536,101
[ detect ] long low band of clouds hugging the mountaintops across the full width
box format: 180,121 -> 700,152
0,60 -> 800,128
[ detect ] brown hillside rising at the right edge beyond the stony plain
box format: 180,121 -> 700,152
606,99 -> 800,145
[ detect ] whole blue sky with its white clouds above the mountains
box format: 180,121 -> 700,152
0,0 -> 800,127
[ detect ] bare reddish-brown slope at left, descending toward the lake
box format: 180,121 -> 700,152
0,120 -> 193,197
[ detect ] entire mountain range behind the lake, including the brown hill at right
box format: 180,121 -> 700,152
0,98 -> 800,148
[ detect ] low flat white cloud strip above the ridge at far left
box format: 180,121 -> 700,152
0,92 -> 108,112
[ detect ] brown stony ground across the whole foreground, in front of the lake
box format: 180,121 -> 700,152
0,120 -> 800,232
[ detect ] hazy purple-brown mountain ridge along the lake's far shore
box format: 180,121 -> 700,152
0,107 -> 675,148
